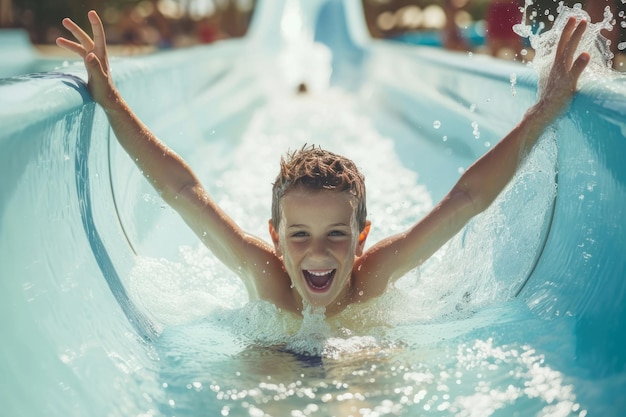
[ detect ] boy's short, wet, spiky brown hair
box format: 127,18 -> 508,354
272,145 -> 367,231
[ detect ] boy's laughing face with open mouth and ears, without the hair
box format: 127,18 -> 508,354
270,188 -> 367,307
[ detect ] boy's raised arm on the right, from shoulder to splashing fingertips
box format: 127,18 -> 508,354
355,18 -> 589,297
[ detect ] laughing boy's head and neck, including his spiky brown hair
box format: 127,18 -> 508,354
269,147 -> 370,314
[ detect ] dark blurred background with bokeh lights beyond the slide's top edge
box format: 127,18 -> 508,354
0,0 -> 626,65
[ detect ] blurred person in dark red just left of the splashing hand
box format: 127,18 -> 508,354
486,0 -> 523,59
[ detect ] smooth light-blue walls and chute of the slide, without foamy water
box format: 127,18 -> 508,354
0,0 -> 626,416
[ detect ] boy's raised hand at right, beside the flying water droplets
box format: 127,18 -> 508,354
537,17 -> 590,118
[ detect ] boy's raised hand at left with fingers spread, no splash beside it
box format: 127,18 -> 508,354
56,10 -> 115,108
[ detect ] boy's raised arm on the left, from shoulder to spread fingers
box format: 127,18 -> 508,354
57,11 -> 276,282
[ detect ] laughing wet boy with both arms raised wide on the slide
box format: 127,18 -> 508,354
57,11 -> 590,316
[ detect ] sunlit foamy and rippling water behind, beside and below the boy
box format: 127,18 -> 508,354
124,84 -> 586,416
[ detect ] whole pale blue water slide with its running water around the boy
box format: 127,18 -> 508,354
0,0 -> 626,416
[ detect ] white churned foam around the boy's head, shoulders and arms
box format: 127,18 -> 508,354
131,83 -> 556,357
